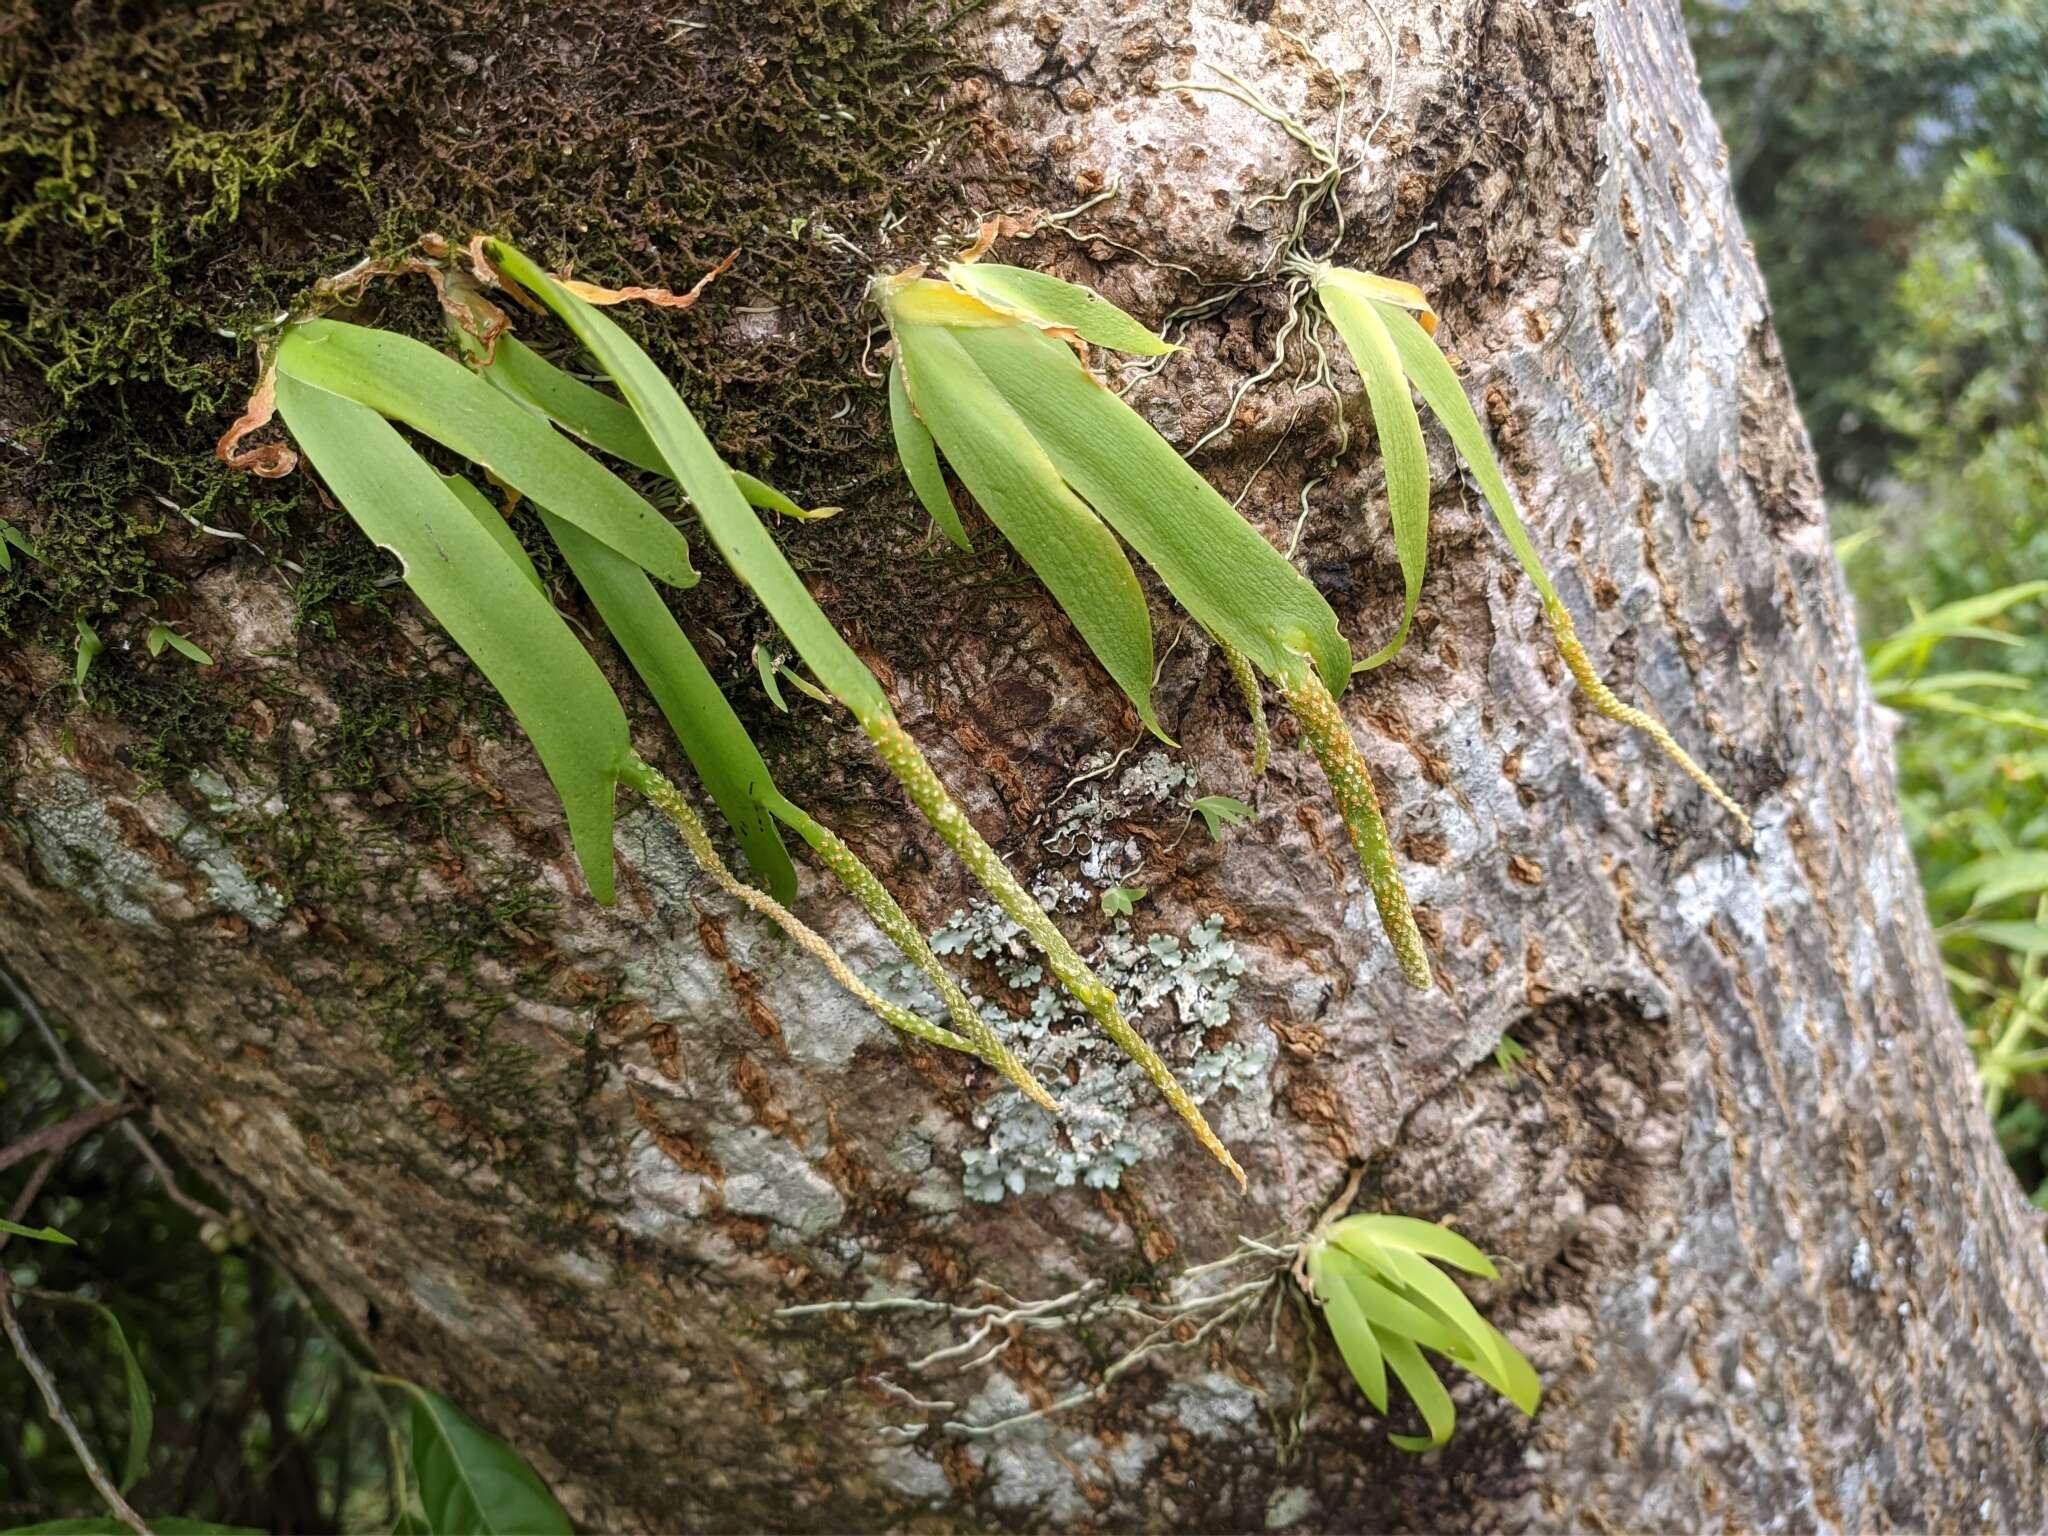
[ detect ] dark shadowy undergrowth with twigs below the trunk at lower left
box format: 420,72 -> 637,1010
0,987 -> 569,1536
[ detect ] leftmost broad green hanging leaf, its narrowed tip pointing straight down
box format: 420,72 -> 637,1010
276,370 -> 631,905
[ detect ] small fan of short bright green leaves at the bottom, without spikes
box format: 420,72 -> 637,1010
1303,1217 -> 1542,1450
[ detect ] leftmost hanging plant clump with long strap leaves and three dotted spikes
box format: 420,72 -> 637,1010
221,238 -> 1243,1184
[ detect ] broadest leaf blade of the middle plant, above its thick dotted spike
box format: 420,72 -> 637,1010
954,326 -> 1352,688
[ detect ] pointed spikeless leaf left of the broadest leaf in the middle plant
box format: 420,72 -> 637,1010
897,326 -> 1165,739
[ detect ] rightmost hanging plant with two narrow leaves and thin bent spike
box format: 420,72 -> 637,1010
1315,266 -> 1751,840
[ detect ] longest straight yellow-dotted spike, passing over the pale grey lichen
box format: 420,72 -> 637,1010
862,716 -> 1245,1188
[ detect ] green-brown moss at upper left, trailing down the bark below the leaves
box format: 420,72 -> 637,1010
0,0 -> 1004,1208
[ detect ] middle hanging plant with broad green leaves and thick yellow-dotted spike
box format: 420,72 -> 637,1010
874,260 -> 1432,987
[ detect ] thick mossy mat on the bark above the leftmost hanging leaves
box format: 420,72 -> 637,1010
0,0 -> 974,708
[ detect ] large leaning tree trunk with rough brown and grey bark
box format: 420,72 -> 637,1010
0,0 -> 2048,1530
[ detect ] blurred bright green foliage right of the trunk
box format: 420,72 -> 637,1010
1688,0 -> 2048,1204
